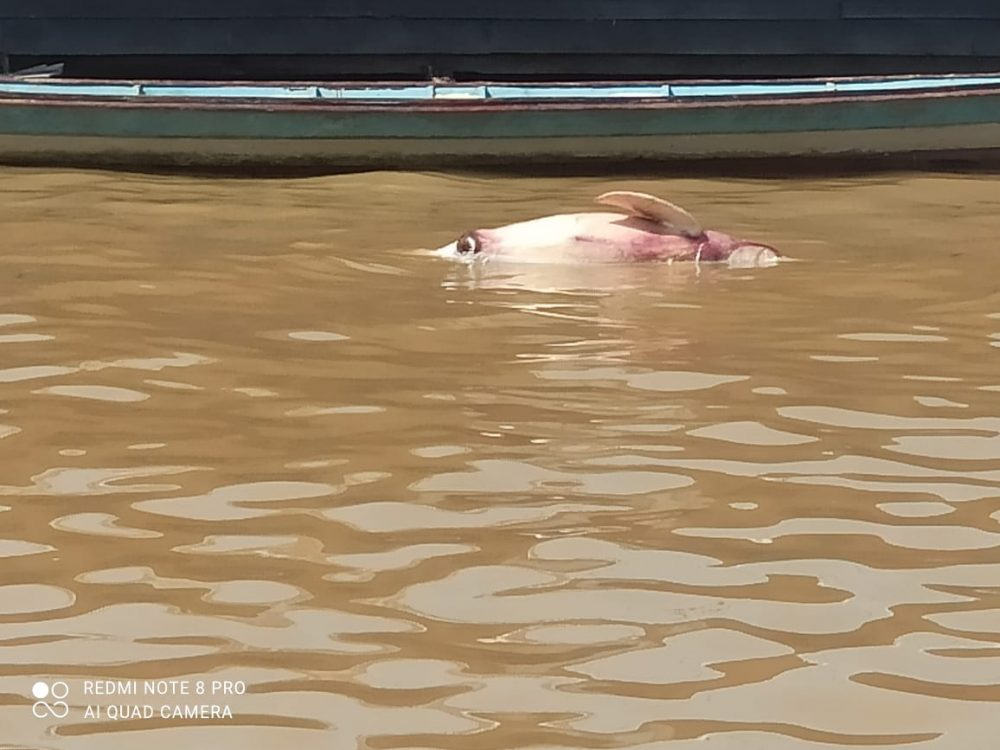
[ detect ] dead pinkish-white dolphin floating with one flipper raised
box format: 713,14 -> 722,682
435,191 -> 780,267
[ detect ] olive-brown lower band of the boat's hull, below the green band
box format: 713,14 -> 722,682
0,124 -> 1000,169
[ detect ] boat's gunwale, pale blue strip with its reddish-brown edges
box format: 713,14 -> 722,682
0,72 -> 1000,112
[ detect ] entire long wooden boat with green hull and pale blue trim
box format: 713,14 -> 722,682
0,73 -> 1000,169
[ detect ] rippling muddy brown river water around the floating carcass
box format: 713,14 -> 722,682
0,170 -> 1000,750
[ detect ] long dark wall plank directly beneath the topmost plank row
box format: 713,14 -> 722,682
0,19 -> 1000,56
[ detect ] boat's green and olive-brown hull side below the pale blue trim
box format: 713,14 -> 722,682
0,76 -> 1000,169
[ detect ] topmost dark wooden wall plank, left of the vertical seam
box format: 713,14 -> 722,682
0,0 -> 840,21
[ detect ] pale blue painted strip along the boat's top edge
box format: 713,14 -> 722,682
0,75 -> 1000,102
